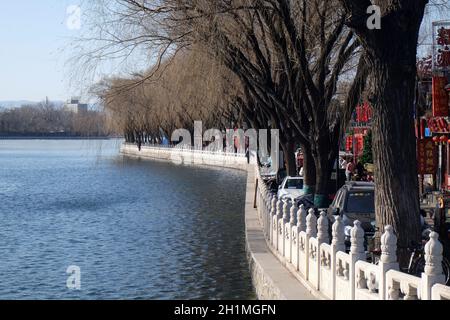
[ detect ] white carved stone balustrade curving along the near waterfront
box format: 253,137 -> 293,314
256,166 -> 450,300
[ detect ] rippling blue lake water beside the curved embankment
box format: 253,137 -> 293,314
0,140 -> 255,300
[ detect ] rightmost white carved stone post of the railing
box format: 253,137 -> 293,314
421,232 -> 445,300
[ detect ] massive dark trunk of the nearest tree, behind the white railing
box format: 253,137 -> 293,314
341,0 -> 428,266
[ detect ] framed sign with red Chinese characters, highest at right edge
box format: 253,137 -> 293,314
433,22 -> 450,72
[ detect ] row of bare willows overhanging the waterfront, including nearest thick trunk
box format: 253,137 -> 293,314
78,0 -> 442,264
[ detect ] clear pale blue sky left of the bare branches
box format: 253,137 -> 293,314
0,0 -> 79,101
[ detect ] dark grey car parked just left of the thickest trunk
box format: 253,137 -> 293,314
328,182 -> 376,249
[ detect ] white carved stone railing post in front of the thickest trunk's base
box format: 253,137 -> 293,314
378,226 -> 400,300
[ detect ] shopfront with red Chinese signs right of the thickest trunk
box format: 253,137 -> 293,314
416,22 -> 450,240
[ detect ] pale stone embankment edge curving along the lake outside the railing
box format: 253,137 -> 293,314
120,144 -> 320,300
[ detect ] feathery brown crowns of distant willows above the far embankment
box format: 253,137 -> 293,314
94,44 -> 242,143
